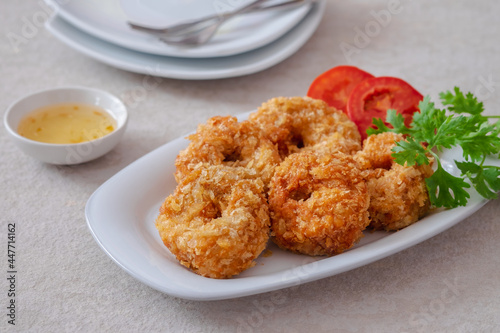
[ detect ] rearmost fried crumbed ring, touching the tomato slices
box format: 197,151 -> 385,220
249,97 -> 361,157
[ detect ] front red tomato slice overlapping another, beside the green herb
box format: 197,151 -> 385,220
347,76 -> 424,139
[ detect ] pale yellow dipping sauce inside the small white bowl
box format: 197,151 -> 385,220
17,103 -> 116,144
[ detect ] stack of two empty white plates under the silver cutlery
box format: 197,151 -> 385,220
42,0 -> 326,80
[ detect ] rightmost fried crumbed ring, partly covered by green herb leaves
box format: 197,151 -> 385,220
355,132 -> 432,231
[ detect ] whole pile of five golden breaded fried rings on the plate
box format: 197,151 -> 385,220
156,97 -> 432,278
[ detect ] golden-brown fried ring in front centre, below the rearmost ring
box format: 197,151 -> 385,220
269,151 -> 370,255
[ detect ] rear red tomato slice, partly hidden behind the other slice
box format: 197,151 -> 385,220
307,66 -> 373,112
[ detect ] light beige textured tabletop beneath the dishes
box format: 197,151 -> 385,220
0,0 -> 500,332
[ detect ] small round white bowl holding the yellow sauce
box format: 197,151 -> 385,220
4,87 -> 128,165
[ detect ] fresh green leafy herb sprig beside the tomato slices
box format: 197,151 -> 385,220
367,87 -> 500,208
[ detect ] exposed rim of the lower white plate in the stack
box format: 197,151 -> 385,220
45,0 -> 326,80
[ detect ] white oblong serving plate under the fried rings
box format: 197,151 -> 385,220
85,111 -> 499,300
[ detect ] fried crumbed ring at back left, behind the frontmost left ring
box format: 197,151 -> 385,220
175,116 -> 281,186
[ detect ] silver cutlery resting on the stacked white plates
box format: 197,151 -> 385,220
128,0 -> 312,46
